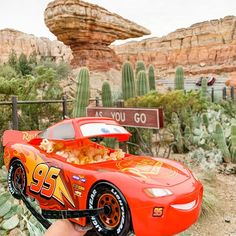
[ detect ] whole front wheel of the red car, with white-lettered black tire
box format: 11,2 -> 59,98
88,182 -> 131,236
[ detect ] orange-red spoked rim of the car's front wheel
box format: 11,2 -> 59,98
98,193 -> 121,228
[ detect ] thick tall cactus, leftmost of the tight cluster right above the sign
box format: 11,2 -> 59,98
122,62 -> 135,100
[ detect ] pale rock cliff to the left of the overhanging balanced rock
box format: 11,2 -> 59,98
0,29 -> 72,64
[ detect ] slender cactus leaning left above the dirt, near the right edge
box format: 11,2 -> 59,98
214,123 -> 231,162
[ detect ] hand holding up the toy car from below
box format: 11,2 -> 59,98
44,220 -> 89,236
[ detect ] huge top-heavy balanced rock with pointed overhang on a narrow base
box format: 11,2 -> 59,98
44,0 -> 150,71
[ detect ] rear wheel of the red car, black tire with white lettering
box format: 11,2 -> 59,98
7,160 -> 26,199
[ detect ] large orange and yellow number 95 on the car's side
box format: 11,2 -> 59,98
30,164 -> 60,198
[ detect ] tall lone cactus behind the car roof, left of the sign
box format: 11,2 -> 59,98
73,67 -> 90,117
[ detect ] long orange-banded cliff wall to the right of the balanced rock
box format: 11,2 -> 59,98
113,16 -> 236,77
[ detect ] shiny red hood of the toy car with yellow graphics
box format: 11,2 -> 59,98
91,155 -> 190,186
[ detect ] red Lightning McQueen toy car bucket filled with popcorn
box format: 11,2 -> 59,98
3,117 -> 203,236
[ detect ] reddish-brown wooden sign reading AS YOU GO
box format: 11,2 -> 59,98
87,107 -> 164,129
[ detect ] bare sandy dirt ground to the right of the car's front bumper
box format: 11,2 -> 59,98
183,174 -> 236,236
